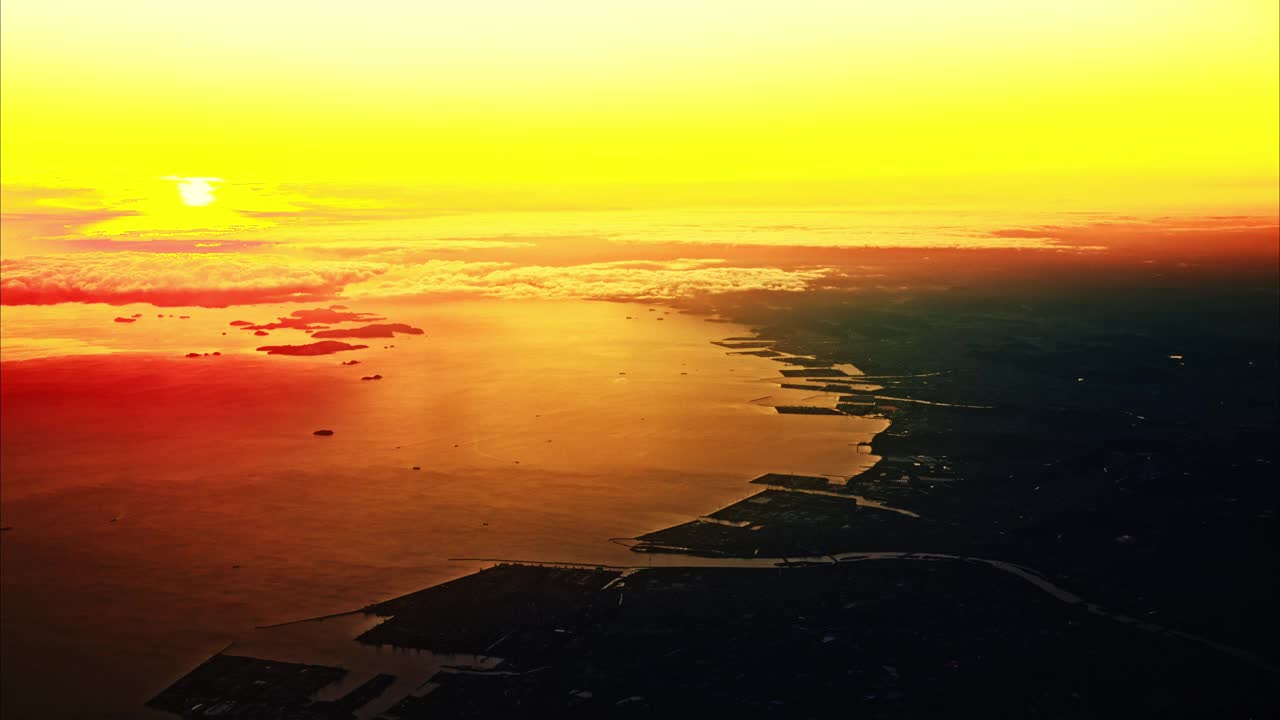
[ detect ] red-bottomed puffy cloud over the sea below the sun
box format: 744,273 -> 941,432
0,252 -> 387,307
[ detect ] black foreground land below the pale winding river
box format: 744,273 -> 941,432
373,560 -> 1268,720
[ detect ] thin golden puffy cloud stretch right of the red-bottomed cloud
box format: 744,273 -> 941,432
346,259 -> 829,300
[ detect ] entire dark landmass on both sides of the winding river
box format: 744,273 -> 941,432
145,251 -> 1280,720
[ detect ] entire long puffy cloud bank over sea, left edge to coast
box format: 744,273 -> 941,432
0,252 -> 828,304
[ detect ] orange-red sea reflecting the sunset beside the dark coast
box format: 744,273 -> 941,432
0,295 -> 883,717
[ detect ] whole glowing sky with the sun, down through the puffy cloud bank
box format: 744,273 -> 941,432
0,0 -> 1280,304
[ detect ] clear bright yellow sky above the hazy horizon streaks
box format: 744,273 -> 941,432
0,0 -> 1280,240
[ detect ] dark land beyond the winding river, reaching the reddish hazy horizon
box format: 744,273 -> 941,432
696,258 -> 1280,662
